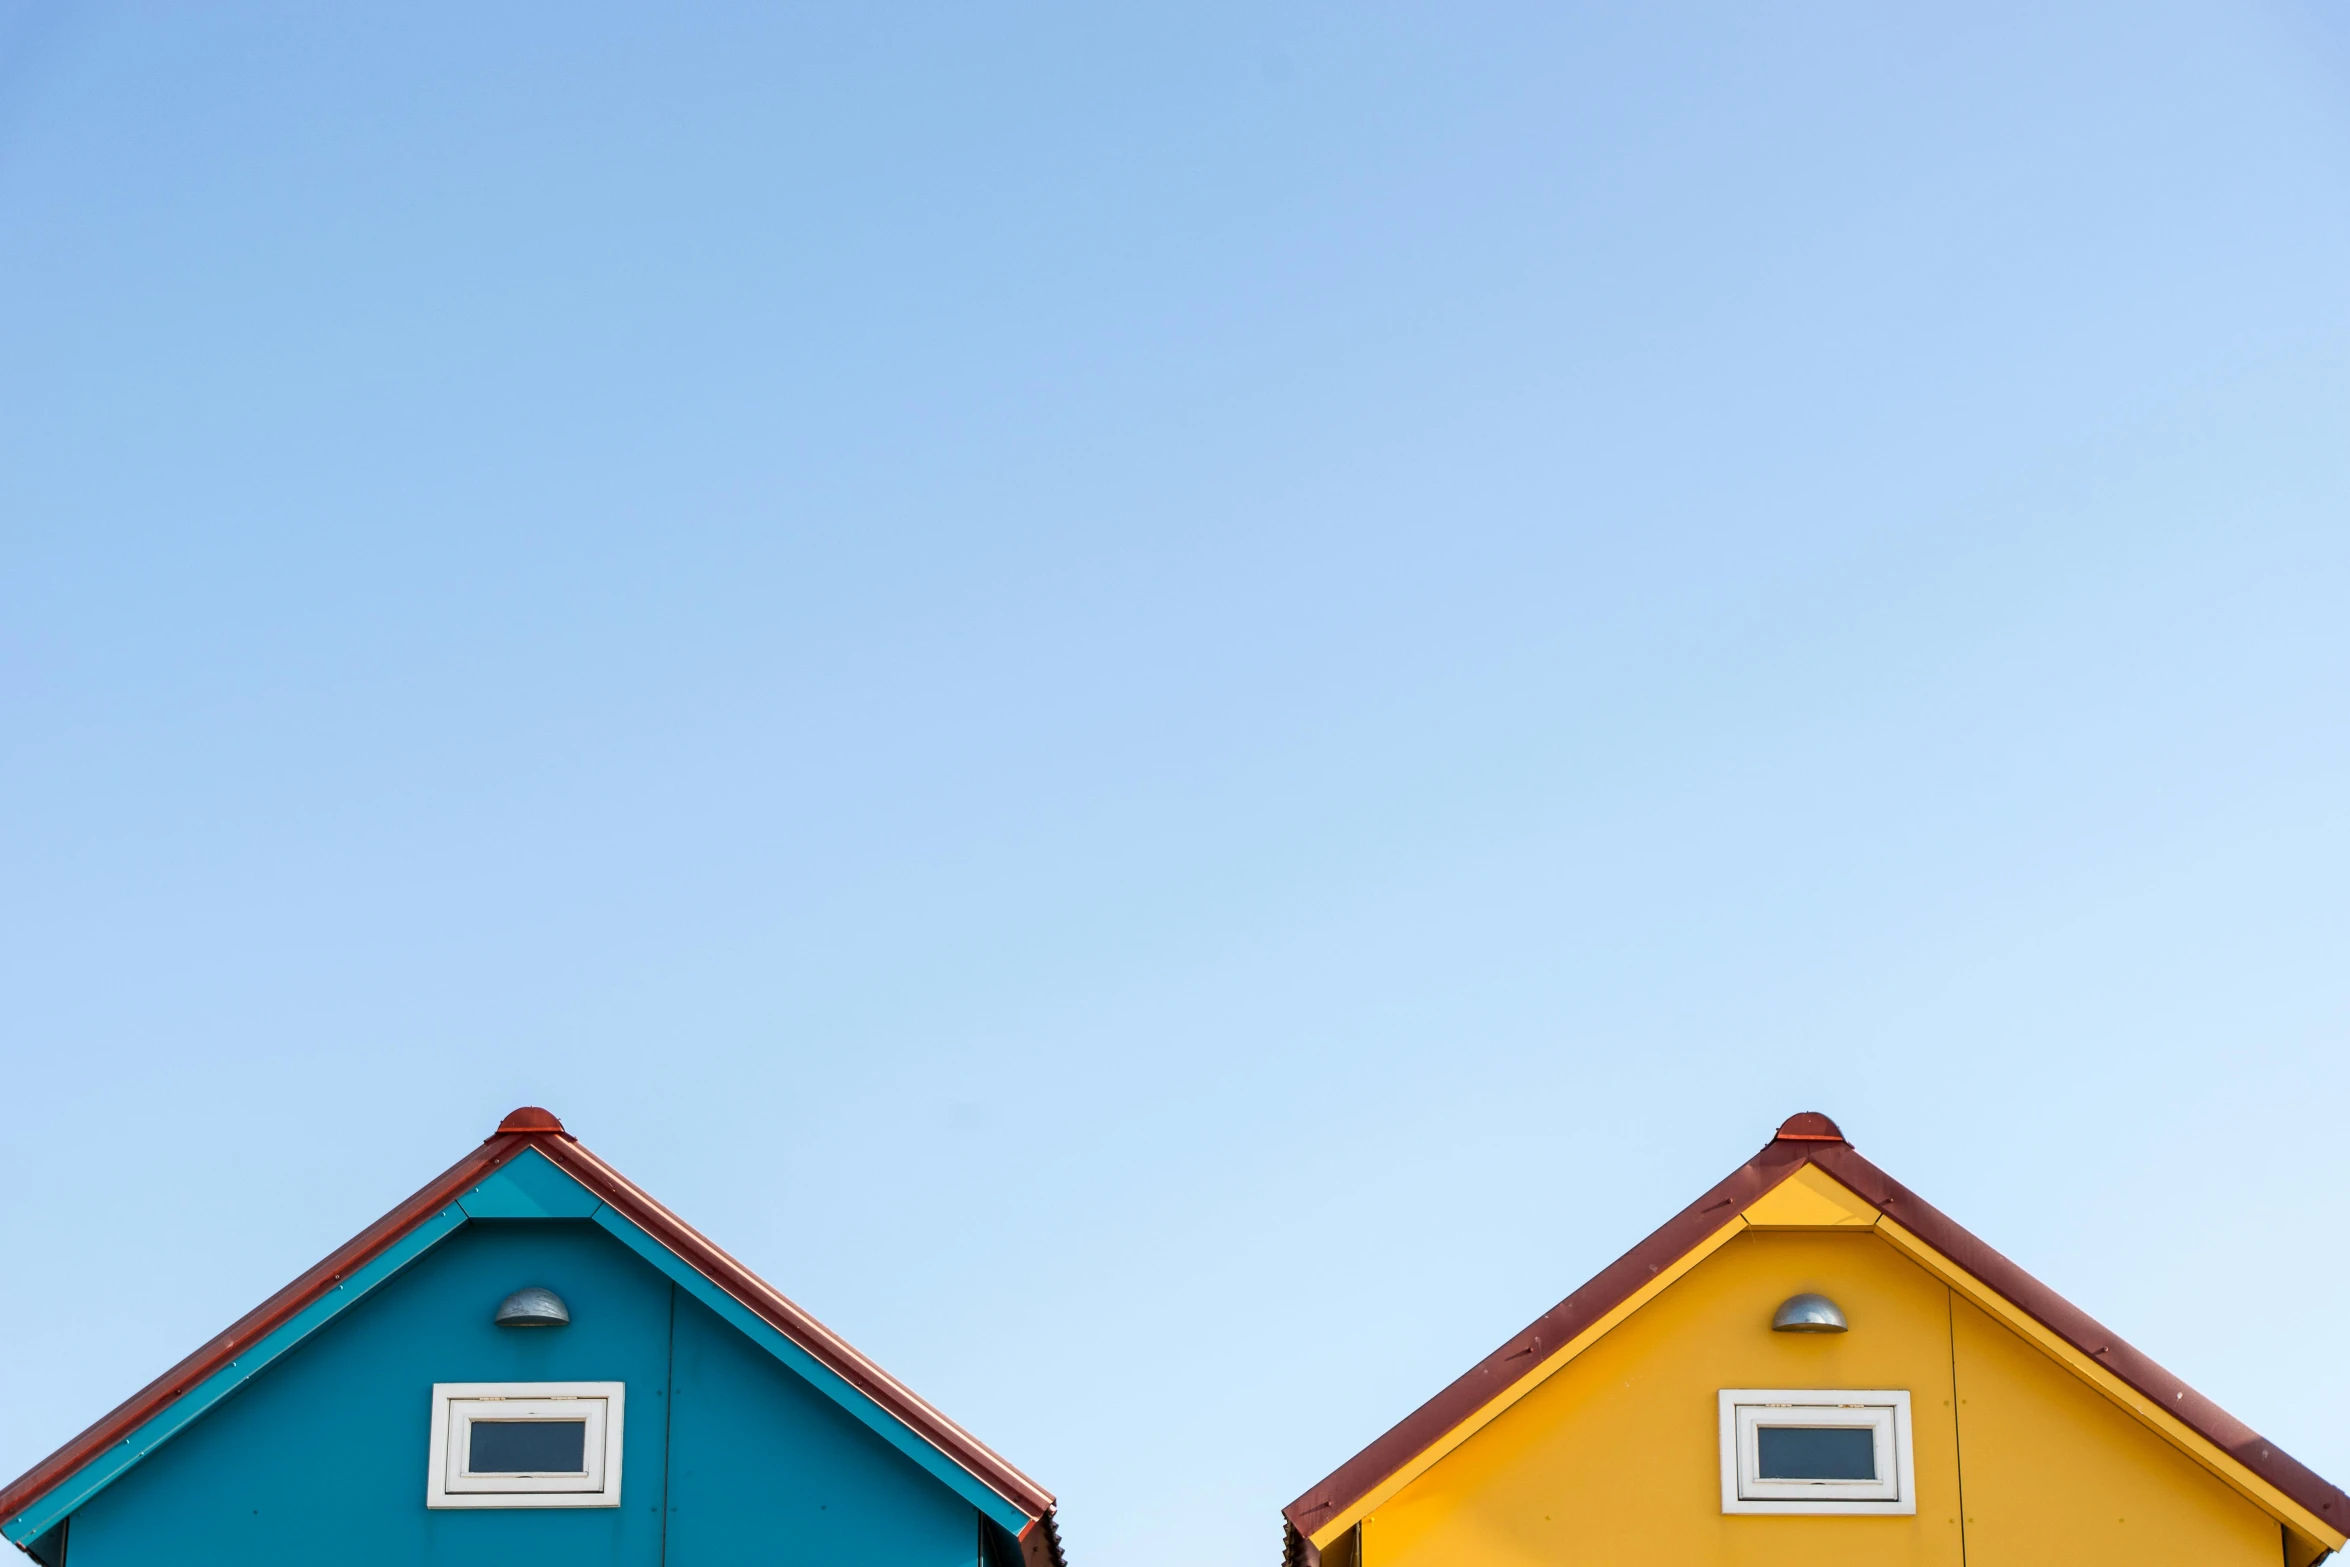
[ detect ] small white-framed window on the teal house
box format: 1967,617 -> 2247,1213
425,1381 -> 627,1508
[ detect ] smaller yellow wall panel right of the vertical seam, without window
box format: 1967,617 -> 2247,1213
1953,1299 -> 2282,1567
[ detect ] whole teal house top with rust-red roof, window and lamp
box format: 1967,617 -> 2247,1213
0,1109 -> 1065,1567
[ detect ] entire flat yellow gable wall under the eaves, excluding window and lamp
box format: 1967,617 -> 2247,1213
1340,1231 -> 2282,1567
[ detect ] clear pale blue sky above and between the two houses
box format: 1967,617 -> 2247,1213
0,0 -> 2350,1567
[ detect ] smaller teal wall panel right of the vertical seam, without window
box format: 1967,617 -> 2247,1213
662,1292 -> 980,1567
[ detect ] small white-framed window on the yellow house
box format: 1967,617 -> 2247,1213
1723,1388 -> 1918,1515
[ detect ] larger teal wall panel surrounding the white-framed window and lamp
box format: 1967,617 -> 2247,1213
71,1219 -> 672,1567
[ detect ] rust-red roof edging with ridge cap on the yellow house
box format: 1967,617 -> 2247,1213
1281,1111 -> 2350,1536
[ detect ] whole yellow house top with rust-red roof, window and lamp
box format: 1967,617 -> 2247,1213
1283,1114 -> 2350,1567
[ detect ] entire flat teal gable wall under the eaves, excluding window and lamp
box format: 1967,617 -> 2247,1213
66,1219 -> 980,1567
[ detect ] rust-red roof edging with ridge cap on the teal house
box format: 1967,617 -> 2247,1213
0,1104 -> 1060,1562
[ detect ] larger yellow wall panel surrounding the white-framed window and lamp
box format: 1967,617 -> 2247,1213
1363,1229 -> 1986,1567
